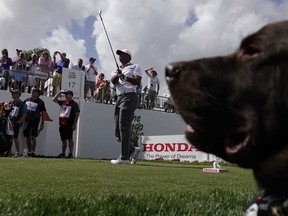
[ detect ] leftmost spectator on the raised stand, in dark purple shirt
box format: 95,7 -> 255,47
0,49 -> 13,90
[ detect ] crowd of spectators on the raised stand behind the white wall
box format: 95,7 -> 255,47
0,49 -> 174,111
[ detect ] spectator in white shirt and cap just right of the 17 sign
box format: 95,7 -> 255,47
84,57 -> 98,99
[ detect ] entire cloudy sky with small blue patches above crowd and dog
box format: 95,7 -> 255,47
0,0 -> 288,93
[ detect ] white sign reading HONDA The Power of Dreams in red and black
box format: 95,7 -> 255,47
139,135 -> 216,162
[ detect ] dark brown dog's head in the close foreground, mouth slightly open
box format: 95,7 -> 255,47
166,21 -> 288,170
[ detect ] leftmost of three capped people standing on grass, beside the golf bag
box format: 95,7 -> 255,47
9,89 -> 27,157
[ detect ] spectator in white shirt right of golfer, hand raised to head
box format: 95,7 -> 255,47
145,68 -> 160,109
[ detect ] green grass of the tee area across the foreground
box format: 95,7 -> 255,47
0,158 -> 258,216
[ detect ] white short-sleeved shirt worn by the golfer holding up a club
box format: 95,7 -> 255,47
112,63 -> 142,95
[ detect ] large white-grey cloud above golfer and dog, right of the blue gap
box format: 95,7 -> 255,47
95,0 -> 288,92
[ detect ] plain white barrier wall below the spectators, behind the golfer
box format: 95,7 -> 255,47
0,90 -> 186,159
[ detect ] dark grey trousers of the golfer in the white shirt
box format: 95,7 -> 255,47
114,93 -> 138,160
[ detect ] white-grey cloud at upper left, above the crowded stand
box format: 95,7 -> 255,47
0,0 -> 101,62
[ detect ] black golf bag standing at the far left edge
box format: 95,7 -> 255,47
0,103 -> 12,156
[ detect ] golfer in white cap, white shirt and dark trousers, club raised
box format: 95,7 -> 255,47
111,49 -> 142,164
